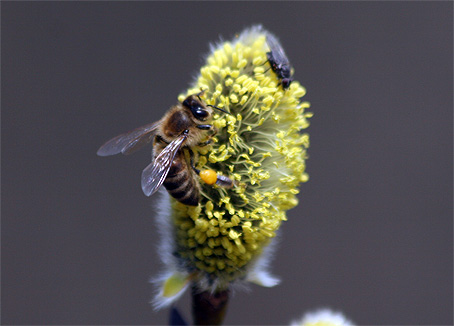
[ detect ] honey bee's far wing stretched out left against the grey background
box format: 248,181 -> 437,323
96,121 -> 161,156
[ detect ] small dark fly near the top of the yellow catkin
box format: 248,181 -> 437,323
266,33 -> 293,90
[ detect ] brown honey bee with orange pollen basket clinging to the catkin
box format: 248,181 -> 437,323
97,91 -> 234,206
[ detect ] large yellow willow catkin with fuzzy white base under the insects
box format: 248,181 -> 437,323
153,26 -> 311,306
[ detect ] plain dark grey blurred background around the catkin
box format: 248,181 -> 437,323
1,2 -> 453,324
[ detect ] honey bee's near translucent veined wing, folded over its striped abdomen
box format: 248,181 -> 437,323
142,133 -> 188,196
